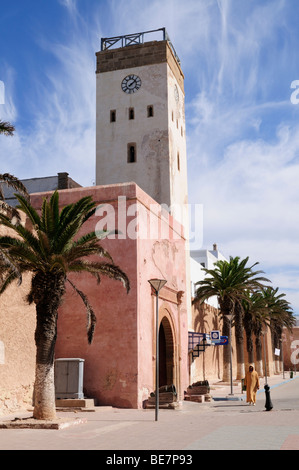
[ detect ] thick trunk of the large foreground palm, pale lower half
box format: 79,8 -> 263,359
31,273 -> 65,420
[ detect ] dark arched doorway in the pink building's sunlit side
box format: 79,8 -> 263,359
159,317 -> 175,387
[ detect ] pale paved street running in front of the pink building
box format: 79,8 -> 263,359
0,375 -> 299,454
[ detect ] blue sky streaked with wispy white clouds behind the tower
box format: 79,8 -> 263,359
0,0 -> 299,314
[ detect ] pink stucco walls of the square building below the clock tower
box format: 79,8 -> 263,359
31,183 -> 188,408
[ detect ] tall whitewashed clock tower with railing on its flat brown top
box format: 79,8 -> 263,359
96,28 -> 188,231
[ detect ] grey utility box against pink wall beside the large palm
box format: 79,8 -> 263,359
54,358 -> 84,399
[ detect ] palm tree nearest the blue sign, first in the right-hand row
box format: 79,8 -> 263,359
195,256 -> 268,381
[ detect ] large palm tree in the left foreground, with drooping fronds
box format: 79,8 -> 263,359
0,191 -> 130,419
